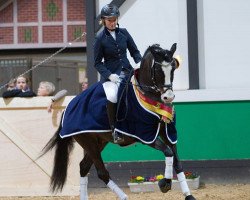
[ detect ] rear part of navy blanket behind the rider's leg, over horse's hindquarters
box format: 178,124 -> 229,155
60,83 -> 110,138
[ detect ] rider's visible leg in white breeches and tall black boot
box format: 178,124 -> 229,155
103,81 -> 124,143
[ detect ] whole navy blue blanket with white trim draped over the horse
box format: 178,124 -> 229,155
60,82 -> 175,144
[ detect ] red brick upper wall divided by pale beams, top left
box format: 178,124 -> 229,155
0,0 -> 86,49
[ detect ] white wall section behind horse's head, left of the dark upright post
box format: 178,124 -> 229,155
119,0 -> 188,89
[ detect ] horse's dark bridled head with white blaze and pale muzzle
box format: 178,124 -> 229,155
138,43 -> 179,103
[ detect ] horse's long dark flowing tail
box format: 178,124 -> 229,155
39,116 -> 74,192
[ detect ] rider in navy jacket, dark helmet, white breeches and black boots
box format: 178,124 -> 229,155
94,4 -> 142,143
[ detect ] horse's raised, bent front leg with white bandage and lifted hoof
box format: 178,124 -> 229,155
150,138 -> 174,193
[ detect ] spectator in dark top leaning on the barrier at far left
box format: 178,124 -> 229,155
3,75 -> 36,98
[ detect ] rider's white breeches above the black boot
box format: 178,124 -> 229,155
102,81 -> 120,103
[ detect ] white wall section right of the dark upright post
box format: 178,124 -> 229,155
197,0 -> 250,89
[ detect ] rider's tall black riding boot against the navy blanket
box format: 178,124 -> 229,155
107,101 -> 124,143
